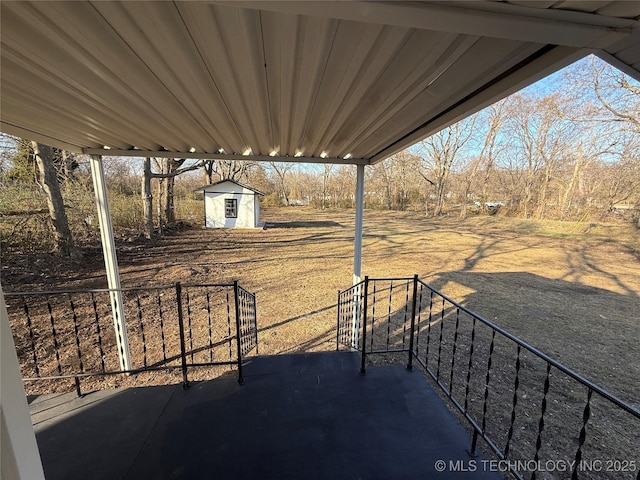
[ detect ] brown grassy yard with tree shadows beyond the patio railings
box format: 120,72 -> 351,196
2,207 -> 640,405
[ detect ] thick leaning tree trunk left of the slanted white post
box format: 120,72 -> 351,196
32,142 -> 73,256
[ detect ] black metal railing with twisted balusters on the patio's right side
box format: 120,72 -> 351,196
337,276 -> 640,479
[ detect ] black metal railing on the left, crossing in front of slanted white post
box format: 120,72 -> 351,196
5,282 -> 258,395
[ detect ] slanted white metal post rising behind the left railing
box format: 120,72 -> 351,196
90,155 -> 131,370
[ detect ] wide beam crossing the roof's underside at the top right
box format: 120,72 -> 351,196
221,1 -> 637,48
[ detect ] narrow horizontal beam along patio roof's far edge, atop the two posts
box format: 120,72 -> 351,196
82,148 -> 370,165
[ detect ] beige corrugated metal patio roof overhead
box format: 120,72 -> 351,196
0,1 -> 640,164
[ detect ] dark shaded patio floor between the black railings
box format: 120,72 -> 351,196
30,352 -> 499,480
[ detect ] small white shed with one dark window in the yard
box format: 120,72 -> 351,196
199,180 -> 264,228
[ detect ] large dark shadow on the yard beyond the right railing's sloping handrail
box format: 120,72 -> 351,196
428,271 -> 640,405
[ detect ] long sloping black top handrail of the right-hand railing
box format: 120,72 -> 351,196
416,279 -> 640,418
